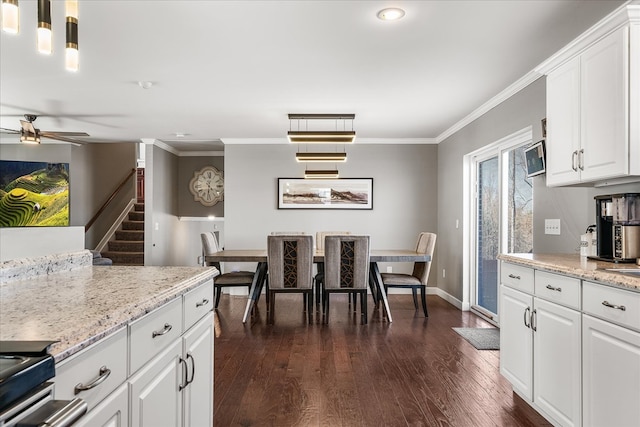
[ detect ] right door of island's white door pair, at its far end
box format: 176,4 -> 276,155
183,312 -> 213,427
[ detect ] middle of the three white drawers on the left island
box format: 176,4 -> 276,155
129,297 -> 182,375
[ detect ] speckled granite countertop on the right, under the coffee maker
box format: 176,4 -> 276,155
498,254 -> 640,292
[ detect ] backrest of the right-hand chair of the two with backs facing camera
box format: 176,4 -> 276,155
324,235 -> 369,289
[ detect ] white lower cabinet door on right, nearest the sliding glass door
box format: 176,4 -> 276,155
500,285 -> 533,401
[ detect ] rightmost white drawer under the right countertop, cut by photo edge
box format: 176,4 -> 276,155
582,282 -> 640,331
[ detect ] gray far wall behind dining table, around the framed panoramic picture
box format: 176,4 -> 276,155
224,144 -> 438,278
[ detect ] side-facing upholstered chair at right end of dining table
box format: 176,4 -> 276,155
380,232 -> 436,317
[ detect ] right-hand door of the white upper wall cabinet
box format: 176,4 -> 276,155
580,27 -> 629,181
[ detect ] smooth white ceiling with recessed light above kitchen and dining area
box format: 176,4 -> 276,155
0,0 -> 625,151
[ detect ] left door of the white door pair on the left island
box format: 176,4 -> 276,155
129,339 -> 184,427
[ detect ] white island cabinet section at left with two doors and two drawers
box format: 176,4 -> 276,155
129,282 -> 213,427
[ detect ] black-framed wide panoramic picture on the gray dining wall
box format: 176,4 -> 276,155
278,178 -> 373,210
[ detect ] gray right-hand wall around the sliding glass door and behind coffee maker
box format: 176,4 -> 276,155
432,78 -> 640,300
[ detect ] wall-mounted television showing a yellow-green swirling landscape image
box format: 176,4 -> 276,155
0,160 -> 69,227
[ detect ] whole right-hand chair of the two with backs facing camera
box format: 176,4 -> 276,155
322,235 -> 369,324
